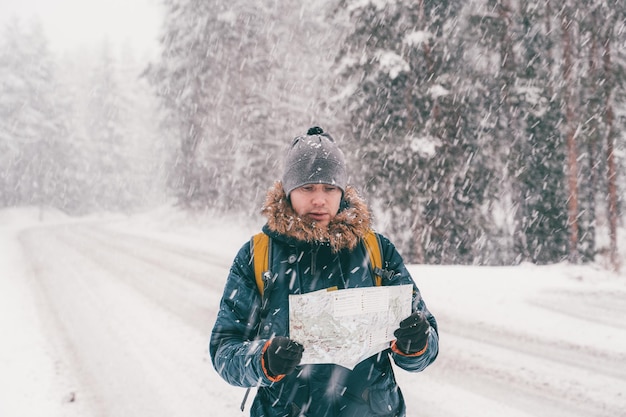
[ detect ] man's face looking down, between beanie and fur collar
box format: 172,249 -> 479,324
289,184 -> 341,227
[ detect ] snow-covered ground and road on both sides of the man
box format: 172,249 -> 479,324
0,208 -> 626,417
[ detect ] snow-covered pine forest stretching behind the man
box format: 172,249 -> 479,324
0,0 -> 626,269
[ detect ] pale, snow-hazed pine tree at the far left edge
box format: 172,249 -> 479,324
0,21 -> 68,214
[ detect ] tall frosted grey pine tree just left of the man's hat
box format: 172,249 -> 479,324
149,0 -> 267,207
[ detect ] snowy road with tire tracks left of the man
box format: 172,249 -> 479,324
12,225 -> 242,417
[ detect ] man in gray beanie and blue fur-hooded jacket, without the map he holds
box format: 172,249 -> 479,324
210,127 -> 439,417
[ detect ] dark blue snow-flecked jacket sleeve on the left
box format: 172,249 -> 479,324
209,240 -> 271,387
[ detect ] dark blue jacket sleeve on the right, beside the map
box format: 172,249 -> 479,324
379,235 -> 439,372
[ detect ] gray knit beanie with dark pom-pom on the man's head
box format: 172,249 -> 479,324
283,126 -> 348,196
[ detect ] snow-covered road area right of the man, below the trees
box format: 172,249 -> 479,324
410,266 -> 626,417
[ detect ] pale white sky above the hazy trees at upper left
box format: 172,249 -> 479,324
0,0 -> 163,52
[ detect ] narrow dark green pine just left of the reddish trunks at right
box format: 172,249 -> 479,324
514,1 -> 568,263
